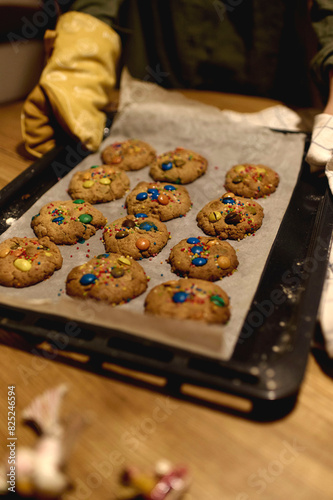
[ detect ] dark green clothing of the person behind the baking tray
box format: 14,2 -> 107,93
62,0 -> 333,106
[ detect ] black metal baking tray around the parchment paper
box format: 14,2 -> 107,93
0,131 -> 333,418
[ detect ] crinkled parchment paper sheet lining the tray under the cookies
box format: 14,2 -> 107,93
0,74 -> 305,359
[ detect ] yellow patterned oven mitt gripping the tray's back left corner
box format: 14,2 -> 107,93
21,11 -> 121,158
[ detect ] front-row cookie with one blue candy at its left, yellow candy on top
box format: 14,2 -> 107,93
66,253 -> 148,305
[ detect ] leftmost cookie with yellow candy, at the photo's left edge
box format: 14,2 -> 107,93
0,237 -> 62,288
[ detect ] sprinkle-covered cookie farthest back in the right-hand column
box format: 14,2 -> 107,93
225,163 -> 280,198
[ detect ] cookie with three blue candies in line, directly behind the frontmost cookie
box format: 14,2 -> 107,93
168,236 -> 238,281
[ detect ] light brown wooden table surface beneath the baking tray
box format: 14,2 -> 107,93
0,92 -> 333,500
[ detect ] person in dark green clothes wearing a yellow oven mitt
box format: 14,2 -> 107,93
22,0 -> 333,170
